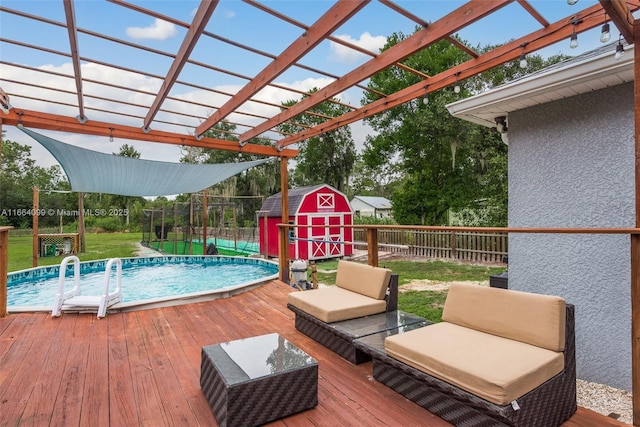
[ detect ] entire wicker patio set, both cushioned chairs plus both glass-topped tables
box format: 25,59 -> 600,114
200,260 -> 577,427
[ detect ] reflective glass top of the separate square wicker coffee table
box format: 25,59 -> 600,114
202,333 -> 318,384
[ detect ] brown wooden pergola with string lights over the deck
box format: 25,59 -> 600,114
0,0 -> 640,426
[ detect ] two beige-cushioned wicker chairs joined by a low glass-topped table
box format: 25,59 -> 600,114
287,261 -> 577,427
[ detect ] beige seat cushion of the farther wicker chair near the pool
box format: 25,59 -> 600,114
287,286 -> 387,323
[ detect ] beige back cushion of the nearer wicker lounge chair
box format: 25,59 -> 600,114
442,284 -> 566,351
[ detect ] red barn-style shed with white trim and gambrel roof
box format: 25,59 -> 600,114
258,184 -> 353,260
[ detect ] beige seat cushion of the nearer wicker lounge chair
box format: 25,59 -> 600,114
385,322 -> 564,405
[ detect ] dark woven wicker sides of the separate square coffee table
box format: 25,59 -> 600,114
200,346 -> 318,427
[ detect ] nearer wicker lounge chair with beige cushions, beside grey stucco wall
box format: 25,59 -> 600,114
356,287 -> 577,427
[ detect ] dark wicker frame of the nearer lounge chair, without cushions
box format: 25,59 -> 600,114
361,304 -> 577,427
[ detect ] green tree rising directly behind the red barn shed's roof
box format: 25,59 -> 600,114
280,89 -> 356,192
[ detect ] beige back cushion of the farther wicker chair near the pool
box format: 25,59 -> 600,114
336,259 -> 391,299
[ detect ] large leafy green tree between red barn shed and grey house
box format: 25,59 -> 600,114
363,34 -> 504,225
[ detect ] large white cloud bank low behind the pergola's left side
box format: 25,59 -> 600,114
0,59 -> 362,167
